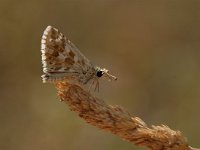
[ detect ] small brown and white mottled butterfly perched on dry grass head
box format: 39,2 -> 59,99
41,26 -> 117,90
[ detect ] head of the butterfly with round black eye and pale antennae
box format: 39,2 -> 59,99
95,67 -> 117,81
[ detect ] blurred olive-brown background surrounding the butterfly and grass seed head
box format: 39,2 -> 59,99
0,0 -> 200,150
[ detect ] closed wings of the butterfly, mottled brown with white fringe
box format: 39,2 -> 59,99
41,26 -> 92,82
